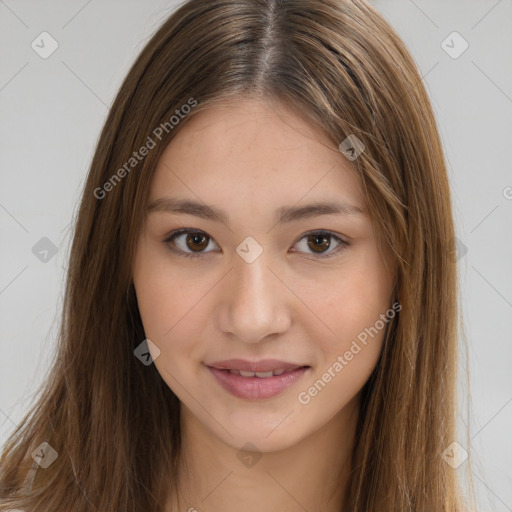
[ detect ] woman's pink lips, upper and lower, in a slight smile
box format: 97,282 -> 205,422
207,359 -> 311,400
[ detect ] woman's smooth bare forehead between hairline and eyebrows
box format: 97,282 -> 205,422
150,100 -> 364,213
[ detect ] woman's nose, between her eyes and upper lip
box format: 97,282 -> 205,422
218,251 -> 293,343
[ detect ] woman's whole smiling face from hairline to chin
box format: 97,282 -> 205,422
133,99 -> 395,452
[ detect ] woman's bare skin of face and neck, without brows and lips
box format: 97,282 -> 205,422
133,98 -> 394,512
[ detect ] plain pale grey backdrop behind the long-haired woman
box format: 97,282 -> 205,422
0,0 -> 512,512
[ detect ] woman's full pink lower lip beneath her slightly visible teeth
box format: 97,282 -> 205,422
207,366 -> 309,399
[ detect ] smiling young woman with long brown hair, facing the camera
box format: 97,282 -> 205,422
0,0 -> 476,512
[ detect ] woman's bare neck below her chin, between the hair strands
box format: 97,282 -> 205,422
165,396 -> 359,512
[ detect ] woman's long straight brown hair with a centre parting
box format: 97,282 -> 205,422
0,0 -> 478,512
